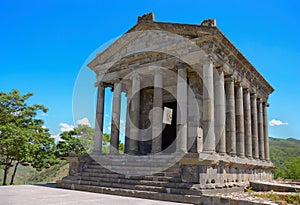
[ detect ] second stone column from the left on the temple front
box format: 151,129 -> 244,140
109,80 -> 121,154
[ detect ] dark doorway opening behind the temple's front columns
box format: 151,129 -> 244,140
161,101 -> 177,153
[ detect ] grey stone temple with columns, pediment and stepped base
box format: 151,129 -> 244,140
58,13 -> 274,204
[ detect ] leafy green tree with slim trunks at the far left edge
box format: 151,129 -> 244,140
0,90 -> 56,185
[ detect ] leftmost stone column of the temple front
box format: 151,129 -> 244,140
94,83 -> 105,154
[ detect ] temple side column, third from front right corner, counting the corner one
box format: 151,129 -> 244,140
225,76 -> 236,156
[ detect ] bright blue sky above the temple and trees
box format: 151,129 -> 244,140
0,0 -> 300,139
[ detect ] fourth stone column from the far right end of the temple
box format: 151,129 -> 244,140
244,89 -> 252,158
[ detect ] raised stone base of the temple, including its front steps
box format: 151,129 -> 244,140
57,153 -> 273,204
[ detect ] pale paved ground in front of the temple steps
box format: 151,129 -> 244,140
0,185 -> 184,205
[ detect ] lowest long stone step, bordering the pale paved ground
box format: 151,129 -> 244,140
57,183 -> 201,204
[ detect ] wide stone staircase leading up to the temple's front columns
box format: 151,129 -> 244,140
57,155 -> 202,204
